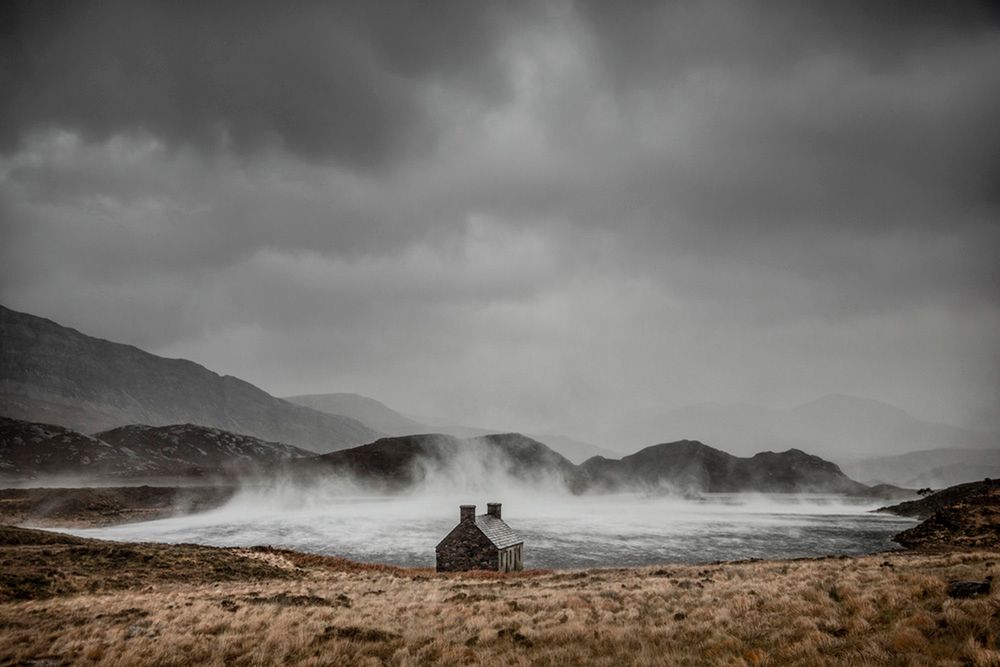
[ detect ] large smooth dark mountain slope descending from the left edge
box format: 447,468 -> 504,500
0,306 -> 381,452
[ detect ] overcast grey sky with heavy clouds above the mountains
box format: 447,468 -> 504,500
0,0 -> 1000,442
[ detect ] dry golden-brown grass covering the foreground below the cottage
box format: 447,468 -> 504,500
0,528 -> 1000,666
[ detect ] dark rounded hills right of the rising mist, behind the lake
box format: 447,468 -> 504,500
574,440 -> 867,494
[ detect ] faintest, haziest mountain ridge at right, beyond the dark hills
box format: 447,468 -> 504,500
620,394 -> 1000,463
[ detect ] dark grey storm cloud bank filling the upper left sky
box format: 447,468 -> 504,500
0,0 -> 540,168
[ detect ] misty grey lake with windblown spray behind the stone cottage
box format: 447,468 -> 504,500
66,478 -> 915,568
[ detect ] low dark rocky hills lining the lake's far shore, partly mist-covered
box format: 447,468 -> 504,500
0,418 -> 868,495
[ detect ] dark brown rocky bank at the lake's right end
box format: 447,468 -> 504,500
879,479 -> 1000,549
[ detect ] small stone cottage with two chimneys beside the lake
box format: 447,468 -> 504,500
435,503 -> 524,572
